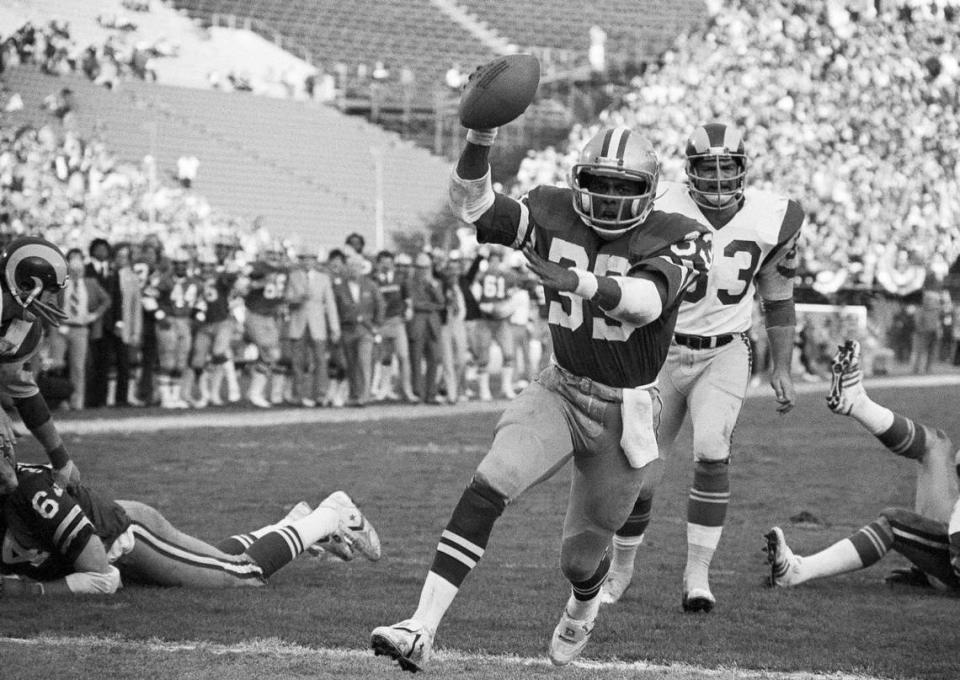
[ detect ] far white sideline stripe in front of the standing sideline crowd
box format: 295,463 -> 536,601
48,374 -> 960,435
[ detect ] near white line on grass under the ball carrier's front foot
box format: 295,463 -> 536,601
0,635 -> 884,680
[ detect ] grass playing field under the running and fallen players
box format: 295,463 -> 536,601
0,386 -> 960,680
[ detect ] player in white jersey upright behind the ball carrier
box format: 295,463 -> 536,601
601,123 -> 803,612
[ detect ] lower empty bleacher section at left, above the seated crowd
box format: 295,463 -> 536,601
4,67 -> 449,247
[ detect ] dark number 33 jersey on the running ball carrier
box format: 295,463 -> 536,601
477,187 -> 710,387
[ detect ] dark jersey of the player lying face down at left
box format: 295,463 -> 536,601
0,465 -> 130,581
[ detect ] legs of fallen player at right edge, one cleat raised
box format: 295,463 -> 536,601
765,340 -> 960,592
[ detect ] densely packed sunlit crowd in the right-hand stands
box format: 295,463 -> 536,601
515,0 -> 960,293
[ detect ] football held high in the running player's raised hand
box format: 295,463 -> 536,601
460,54 -> 540,130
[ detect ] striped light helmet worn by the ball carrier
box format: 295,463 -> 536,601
568,126 -> 660,239
